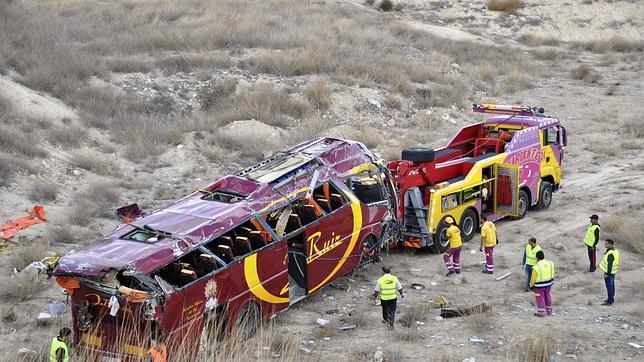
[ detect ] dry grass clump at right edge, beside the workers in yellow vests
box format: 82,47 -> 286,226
602,215 -> 644,255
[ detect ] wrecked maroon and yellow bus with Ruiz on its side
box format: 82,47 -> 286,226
55,138 -> 397,359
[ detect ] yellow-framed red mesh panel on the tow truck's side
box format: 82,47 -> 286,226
493,164 -> 519,217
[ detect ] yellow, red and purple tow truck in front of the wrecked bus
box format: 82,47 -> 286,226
387,104 -> 567,253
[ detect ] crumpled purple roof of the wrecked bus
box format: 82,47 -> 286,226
56,138 -> 376,276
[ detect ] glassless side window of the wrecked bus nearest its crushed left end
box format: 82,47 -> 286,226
153,249 -> 221,288
